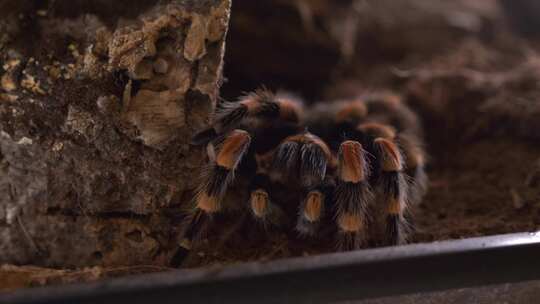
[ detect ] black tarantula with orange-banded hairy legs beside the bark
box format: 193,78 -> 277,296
172,90 -> 426,260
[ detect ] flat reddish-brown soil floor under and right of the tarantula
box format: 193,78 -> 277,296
179,134 -> 540,267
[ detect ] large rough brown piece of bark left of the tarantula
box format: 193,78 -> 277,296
0,0 -> 230,267
